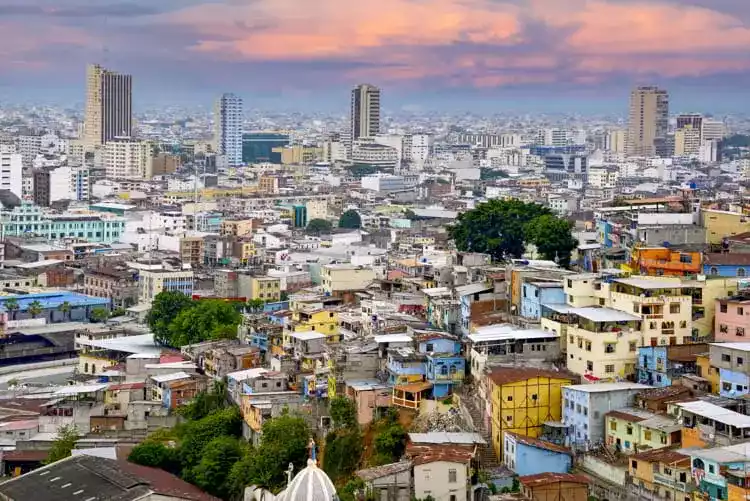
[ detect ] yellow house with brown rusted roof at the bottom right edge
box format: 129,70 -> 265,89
628,449 -> 695,501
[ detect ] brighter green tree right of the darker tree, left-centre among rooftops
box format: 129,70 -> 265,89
168,300 -> 242,348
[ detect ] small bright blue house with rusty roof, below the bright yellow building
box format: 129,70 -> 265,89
503,431 -> 573,476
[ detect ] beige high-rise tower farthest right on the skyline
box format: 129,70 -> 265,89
625,87 -> 672,157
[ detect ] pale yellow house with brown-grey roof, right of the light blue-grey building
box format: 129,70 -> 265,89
605,408 -> 682,454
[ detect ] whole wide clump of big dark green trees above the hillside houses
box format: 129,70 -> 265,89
449,200 -> 577,265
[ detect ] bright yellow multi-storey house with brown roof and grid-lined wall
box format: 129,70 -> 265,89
487,367 -> 576,460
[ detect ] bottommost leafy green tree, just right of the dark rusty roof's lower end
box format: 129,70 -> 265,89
191,437 -> 242,499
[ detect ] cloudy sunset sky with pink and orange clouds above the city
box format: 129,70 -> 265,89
0,0 -> 750,113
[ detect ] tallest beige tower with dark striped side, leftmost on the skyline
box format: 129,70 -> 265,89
83,64 -> 133,150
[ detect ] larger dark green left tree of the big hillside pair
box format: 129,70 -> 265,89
448,200 -> 552,261
